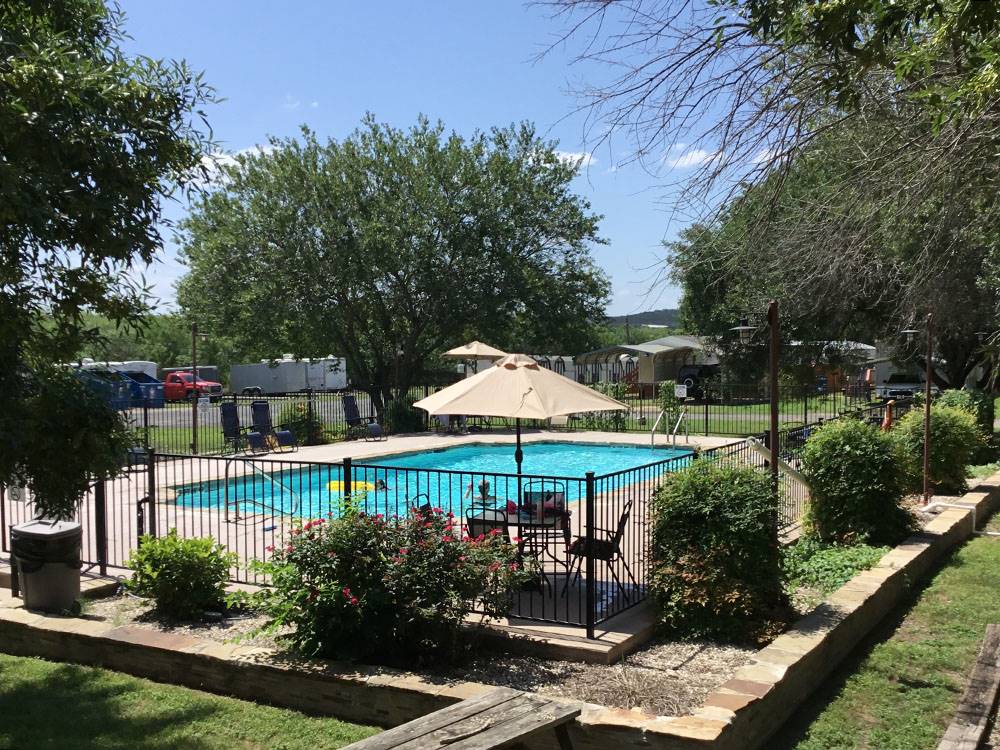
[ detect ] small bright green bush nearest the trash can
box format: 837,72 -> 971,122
126,529 -> 237,619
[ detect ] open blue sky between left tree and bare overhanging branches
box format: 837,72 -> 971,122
122,0 -> 696,315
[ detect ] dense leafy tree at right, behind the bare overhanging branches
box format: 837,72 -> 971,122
669,115 -> 1000,387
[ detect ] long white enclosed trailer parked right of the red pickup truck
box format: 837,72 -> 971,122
229,354 -> 347,396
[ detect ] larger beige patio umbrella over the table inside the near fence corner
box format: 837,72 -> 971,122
413,354 -> 628,474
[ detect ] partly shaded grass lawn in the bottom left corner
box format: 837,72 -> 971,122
0,654 -> 377,750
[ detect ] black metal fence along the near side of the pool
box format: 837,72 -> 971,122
0,400 -> 911,636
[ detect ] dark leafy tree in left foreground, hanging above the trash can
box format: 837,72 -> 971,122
0,0 -> 211,502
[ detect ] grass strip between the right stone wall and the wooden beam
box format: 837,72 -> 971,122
769,538 -> 1000,750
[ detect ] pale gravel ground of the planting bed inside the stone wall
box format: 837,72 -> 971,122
84,595 -> 755,716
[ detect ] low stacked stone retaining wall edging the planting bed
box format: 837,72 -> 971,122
0,473 -> 1000,750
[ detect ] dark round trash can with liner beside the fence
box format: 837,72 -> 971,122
10,519 -> 83,612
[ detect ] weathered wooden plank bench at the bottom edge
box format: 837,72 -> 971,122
349,688 -> 581,750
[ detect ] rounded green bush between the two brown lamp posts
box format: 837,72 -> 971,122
802,418 -> 914,544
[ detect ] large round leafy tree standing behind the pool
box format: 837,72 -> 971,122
178,116 -> 608,413
